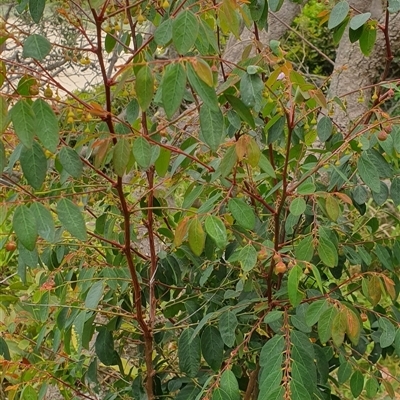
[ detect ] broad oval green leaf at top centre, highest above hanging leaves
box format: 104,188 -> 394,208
172,10 -> 199,55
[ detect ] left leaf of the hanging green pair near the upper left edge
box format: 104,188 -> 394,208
10,100 -> 36,148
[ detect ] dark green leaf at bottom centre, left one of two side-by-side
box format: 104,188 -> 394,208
178,328 -> 201,378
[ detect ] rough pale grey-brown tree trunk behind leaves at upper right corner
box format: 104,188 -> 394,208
329,0 -> 400,131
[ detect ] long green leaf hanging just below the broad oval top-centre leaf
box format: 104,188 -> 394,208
161,63 -> 186,118
